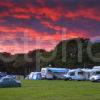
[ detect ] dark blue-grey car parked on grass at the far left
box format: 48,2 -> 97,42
0,76 -> 21,87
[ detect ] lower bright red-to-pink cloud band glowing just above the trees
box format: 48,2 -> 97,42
0,26 -> 88,53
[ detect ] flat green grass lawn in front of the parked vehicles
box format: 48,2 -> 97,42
0,80 -> 100,100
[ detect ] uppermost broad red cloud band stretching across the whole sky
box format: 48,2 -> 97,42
0,0 -> 100,21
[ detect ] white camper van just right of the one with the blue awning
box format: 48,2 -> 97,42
64,69 -> 86,81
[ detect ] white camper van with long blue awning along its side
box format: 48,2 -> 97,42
41,67 -> 68,79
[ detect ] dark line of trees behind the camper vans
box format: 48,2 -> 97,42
0,38 -> 100,75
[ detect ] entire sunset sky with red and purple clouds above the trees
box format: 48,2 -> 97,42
0,0 -> 100,53
